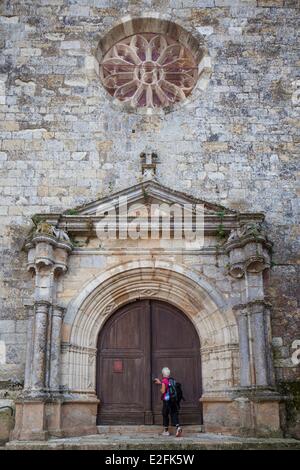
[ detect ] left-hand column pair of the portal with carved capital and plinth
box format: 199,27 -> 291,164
12,225 -> 72,440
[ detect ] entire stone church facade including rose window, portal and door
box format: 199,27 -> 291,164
0,0 -> 300,440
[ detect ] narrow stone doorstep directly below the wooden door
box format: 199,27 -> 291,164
97,424 -> 204,436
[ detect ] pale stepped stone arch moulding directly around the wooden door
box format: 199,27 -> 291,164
62,260 -> 238,396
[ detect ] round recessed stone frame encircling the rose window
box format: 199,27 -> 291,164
95,13 -> 212,115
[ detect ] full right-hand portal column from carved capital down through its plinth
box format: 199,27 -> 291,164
224,222 -> 281,435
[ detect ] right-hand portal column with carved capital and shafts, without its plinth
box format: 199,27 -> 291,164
225,222 -> 271,387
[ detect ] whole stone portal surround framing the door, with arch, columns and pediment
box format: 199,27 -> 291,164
14,182 -> 279,439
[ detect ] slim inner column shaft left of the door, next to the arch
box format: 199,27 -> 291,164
49,305 -> 64,392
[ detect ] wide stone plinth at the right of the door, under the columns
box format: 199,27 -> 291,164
200,389 -> 283,437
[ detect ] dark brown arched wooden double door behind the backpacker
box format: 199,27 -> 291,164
97,300 -> 202,424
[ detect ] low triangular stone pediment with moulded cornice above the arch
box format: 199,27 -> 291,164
29,181 -> 264,236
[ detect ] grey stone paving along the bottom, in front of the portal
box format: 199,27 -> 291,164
4,427 -> 300,450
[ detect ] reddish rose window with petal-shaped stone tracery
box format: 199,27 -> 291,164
100,33 -> 197,108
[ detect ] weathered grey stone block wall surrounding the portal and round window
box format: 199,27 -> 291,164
0,0 -> 300,438
